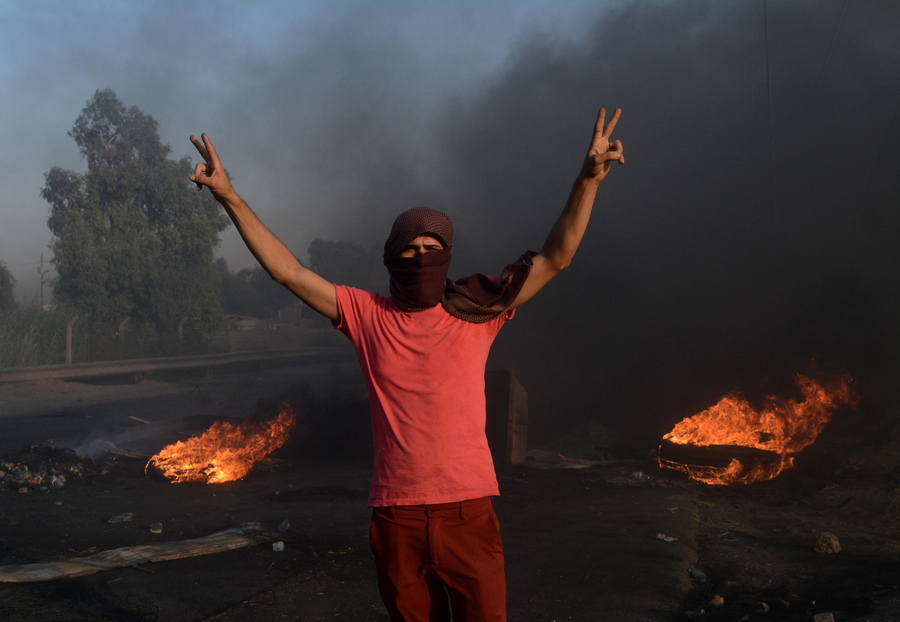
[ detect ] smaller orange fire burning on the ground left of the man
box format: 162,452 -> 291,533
144,405 -> 297,484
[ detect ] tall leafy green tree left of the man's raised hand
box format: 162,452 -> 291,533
41,89 -> 228,348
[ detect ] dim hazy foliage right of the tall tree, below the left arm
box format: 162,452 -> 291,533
216,259 -> 299,319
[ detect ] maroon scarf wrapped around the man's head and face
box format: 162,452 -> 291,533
384,207 -> 453,311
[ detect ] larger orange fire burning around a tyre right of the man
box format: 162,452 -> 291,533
659,374 -> 858,484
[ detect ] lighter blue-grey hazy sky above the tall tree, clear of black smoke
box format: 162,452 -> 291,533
0,0 -> 615,298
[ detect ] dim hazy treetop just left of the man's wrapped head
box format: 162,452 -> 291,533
307,238 -> 388,291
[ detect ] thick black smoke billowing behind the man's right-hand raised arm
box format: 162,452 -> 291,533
428,2 -> 900,446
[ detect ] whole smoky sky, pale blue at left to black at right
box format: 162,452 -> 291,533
0,0 -> 900,442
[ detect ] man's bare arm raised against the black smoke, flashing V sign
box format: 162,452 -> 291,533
512,108 -> 625,308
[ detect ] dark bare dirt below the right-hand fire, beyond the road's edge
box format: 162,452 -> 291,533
685,412 -> 900,622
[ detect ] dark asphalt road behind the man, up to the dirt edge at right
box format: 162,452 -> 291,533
0,366 -> 698,622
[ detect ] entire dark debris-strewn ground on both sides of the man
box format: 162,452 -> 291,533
0,369 -> 900,622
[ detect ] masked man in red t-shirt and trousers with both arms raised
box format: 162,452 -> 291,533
191,109 -> 625,622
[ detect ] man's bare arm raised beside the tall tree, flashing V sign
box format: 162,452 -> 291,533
191,134 -> 340,321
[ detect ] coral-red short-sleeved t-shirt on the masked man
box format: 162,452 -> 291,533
335,285 -> 514,507
